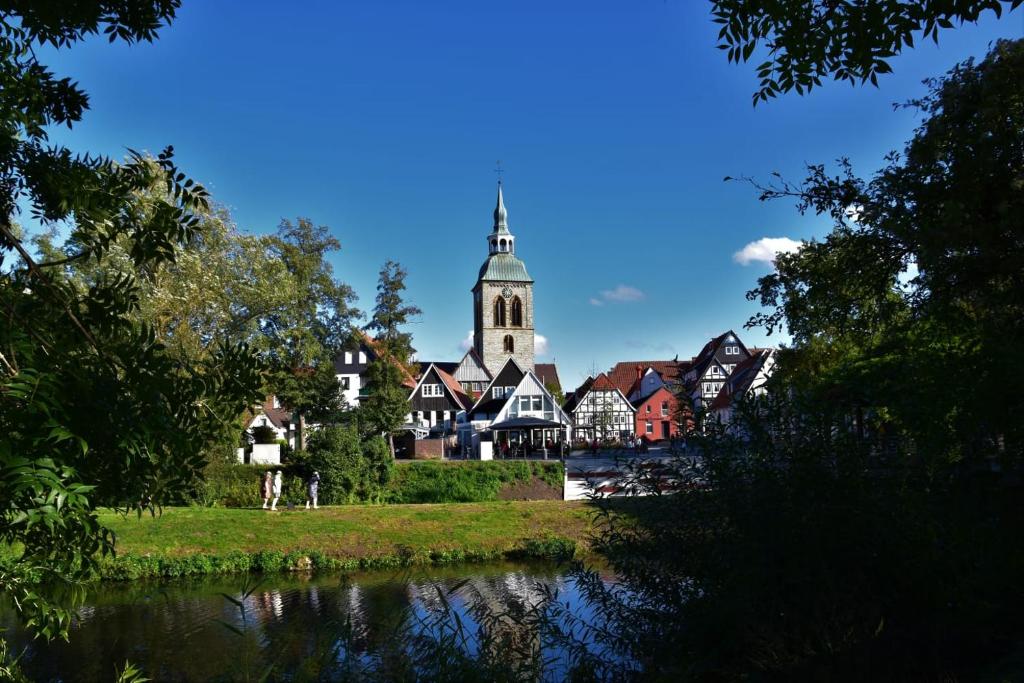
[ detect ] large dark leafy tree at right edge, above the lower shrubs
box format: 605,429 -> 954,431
749,41 -> 1024,460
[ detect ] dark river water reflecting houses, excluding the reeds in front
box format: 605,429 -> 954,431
0,563 -> 587,681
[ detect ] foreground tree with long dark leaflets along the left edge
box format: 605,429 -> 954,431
0,0 -> 262,637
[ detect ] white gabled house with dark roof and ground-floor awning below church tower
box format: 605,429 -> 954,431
459,357 -> 572,460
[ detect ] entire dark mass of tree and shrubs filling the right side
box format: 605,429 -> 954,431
561,40 -> 1024,680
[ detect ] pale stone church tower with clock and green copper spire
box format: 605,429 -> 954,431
473,180 -> 534,375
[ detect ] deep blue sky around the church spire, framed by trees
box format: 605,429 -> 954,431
36,0 -> 1024,387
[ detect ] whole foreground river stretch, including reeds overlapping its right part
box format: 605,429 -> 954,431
0,564 -> 614,681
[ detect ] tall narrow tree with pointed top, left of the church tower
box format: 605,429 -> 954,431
360,260 -> 422,457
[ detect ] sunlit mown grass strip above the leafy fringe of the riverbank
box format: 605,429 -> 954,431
100,501 -> 592,560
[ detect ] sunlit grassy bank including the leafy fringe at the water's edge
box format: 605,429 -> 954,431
100,501 -> 591,580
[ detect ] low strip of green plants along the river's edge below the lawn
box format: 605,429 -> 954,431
100,537 -> 577,581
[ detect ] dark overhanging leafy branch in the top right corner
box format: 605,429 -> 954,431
712,0 -> 1024,104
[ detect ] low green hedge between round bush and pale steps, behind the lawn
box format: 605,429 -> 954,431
387,461 -> 563,503
